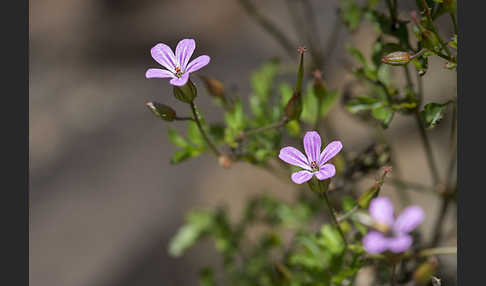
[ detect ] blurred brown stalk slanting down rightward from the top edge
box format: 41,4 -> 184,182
239,0 -> 296,58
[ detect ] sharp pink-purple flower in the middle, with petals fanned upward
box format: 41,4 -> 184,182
278,131 -> 343,184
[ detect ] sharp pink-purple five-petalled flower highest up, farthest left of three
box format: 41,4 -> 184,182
145,39 -> 210,86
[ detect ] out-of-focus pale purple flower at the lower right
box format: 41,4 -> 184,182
363,197 -> 424,254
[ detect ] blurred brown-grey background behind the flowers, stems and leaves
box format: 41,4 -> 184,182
29,0 -> 456,286
